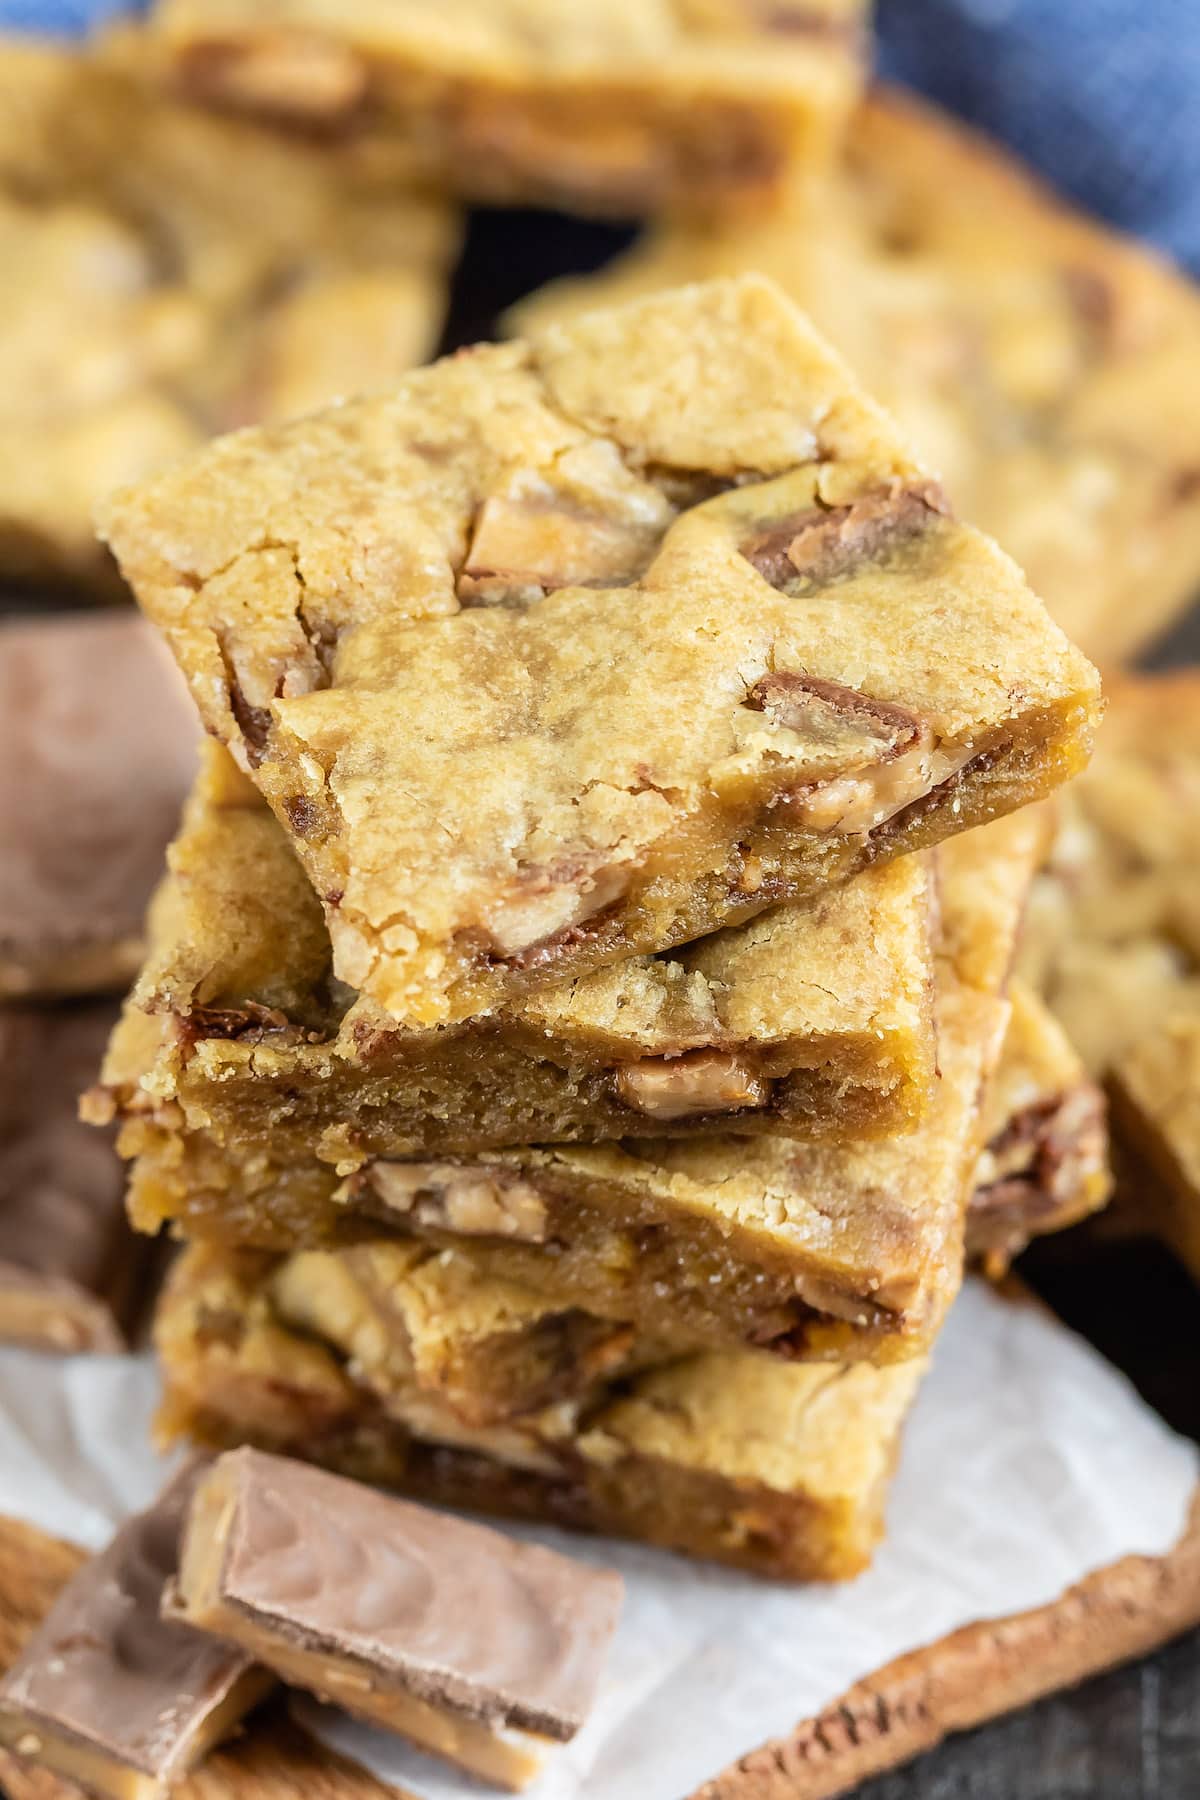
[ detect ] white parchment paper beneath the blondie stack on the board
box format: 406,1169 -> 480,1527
0,1285 -> 1200,1800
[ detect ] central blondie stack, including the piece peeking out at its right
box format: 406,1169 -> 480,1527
88,277 -> 1105,1577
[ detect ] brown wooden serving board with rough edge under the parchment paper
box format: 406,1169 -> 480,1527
0,1490 -> 1200,1800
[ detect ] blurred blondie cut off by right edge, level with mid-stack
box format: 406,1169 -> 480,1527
1024,670 -> 1200,1267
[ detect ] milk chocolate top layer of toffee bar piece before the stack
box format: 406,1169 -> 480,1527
208,1449 -> 621,1739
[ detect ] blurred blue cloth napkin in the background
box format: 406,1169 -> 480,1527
0,0 -> 1200,272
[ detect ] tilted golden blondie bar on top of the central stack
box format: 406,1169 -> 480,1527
104,277 -> 1099,1024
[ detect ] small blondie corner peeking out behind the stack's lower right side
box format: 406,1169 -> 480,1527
966,981 -> 1112,1273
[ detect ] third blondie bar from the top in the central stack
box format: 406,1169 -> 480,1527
103,812 -> 1045,1361
